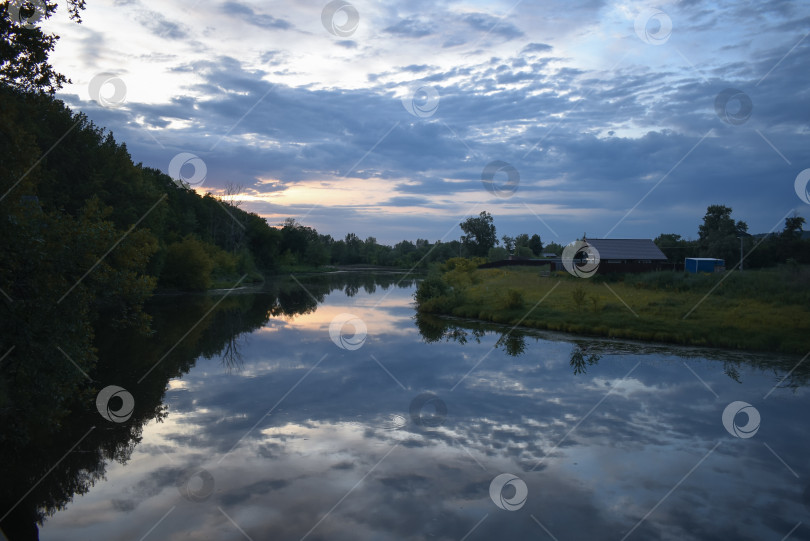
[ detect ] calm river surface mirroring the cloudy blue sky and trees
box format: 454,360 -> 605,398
0,275 -> 810,541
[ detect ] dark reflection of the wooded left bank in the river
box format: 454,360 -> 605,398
0,273 -> 415,541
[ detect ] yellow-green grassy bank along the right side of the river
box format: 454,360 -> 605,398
416,260 -> 810,354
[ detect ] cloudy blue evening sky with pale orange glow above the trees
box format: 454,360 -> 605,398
41,0 -> 810,244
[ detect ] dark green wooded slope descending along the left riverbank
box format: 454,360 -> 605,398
0,86 -> 561,298
